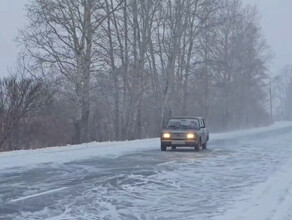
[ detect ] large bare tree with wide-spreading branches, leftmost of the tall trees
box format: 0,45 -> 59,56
20,0 -> 122,143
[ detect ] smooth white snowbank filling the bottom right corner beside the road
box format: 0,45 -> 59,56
215,156 -> 292,220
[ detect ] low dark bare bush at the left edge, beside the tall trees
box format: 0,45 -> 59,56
0,71 -> 48,151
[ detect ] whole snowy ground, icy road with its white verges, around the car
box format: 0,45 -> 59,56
0,123 -> 292,220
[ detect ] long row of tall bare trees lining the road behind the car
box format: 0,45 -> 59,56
0,0 -> 270,149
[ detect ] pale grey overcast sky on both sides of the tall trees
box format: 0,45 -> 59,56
0,0 -> 292,76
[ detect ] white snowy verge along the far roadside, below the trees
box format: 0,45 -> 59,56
0,122 -> 292,170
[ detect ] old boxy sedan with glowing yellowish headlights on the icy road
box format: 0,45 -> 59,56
160,116 -> 209,151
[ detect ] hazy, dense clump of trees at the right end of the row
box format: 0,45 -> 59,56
200,0 -> 270,129
